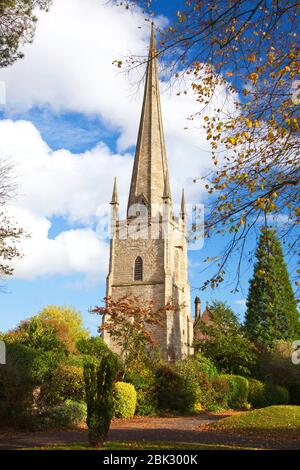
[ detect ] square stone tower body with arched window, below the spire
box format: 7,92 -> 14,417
104,214 -> 193,361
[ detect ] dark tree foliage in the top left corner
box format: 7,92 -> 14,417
0,0 -> 52,67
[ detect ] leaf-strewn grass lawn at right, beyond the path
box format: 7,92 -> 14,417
209,406 -> 300,438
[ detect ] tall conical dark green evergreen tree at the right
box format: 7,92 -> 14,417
245,229 -> 300,346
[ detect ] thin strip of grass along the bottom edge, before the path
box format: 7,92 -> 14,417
21,441 -> 249,450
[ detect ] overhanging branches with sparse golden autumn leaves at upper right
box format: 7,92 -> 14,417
122,0 -> 300,287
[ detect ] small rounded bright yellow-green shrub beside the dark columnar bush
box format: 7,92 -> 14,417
113,382 -> 137,418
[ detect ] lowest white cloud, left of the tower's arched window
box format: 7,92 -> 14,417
10,207 -> 108,279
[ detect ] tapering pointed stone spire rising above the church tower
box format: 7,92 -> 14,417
128,23 -> 171,216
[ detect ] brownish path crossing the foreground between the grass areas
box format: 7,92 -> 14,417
0,414 -> 300,450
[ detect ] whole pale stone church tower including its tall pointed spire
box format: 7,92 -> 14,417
103,25 -> 193,361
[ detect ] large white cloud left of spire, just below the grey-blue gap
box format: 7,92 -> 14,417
0,120 -> 132,223
